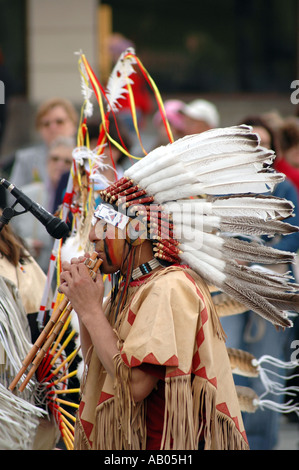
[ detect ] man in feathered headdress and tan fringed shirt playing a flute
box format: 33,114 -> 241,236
60,119 -> 298,449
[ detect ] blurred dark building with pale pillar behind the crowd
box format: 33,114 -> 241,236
0,0 -> 299,159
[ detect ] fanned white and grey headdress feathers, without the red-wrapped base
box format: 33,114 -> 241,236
125,126 -> 298,327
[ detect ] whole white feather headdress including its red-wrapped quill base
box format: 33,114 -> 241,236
101,125 -> 299,327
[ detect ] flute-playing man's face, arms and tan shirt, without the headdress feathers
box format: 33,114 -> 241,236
60,196 -> 251,450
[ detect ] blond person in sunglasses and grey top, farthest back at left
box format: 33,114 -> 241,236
9,98 -> 78,189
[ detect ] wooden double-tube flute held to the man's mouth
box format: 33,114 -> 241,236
8,252 -> 103,392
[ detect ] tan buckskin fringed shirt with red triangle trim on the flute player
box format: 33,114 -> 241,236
75,266 -> 248,450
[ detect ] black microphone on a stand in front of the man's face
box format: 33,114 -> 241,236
0,178 -> 69,239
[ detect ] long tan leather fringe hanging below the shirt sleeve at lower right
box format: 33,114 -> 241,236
161,376 -> 249,450
